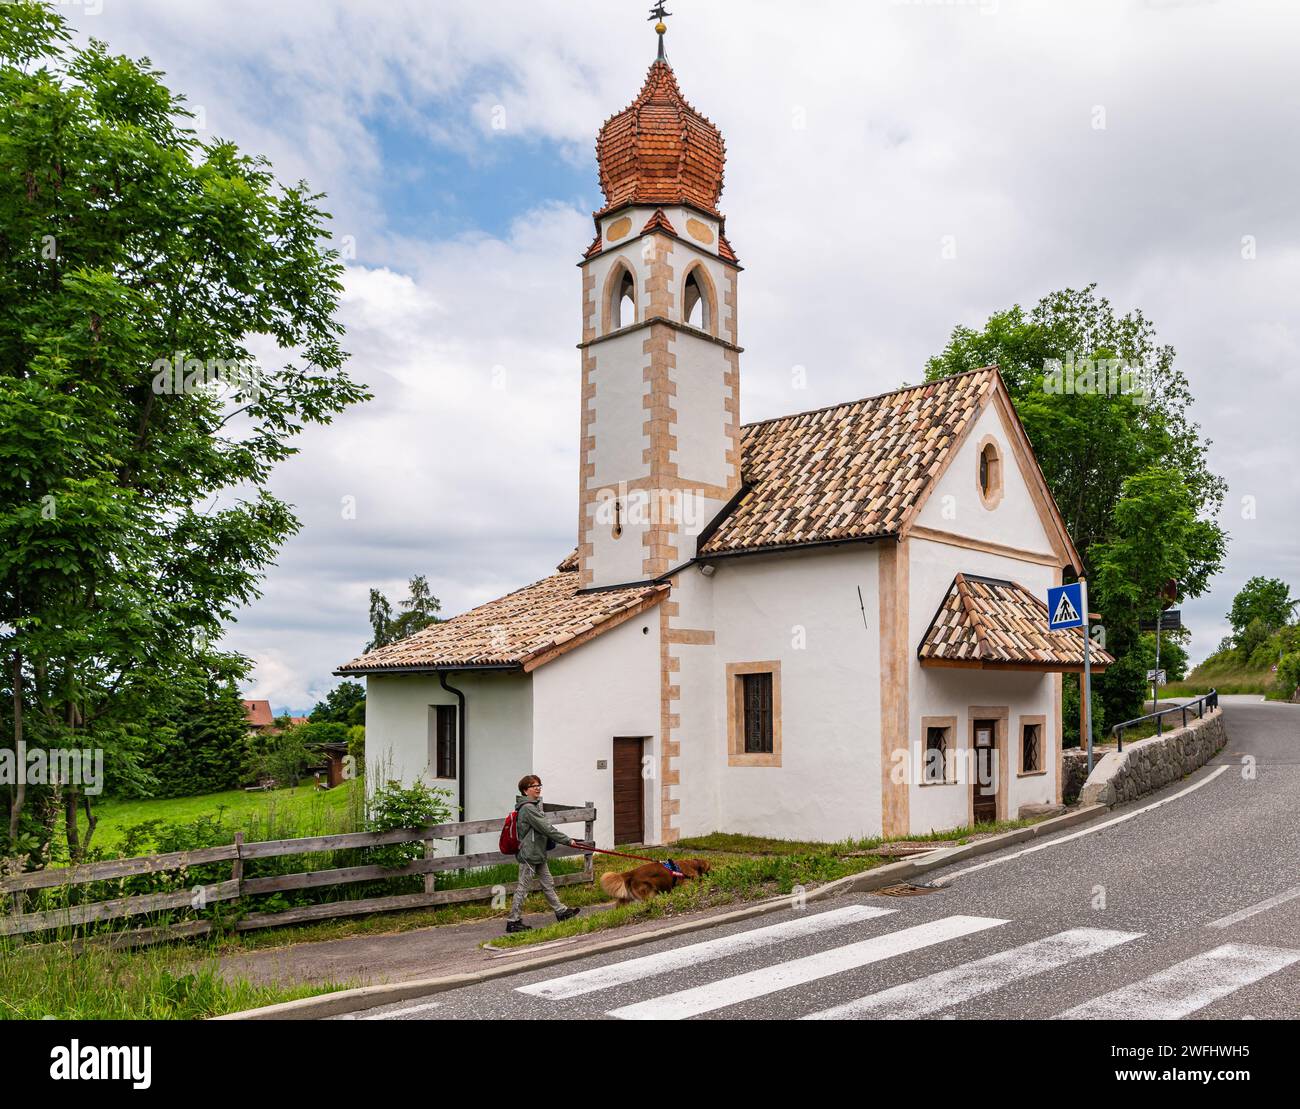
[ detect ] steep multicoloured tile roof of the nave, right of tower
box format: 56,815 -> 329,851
698,367 -> 997,556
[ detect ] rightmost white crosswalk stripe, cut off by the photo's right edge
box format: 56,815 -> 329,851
1054,944 -> 1300,1021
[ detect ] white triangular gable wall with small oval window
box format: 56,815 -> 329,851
917,402 -> 1052,554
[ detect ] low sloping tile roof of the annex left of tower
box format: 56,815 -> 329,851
337,573 -> 668,673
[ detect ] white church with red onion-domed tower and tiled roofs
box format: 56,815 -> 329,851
337,38 -> 1113,849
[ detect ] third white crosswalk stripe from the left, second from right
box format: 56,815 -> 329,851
802,928 -> 1143,1021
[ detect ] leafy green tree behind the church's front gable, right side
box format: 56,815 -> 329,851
926,285 -> 1226,727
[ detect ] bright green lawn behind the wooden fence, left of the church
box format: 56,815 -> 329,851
67,779 -> 363,854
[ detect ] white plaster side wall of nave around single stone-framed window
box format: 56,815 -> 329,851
707,543 -> 881,840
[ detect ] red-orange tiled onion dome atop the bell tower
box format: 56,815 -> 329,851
595,59 -> 727,216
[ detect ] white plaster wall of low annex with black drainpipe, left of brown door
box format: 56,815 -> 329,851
365,671 -> 533,854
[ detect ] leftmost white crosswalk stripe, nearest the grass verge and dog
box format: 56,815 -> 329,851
517,905 -> 898,1000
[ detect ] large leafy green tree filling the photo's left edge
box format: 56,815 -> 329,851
0,3 -> 367,857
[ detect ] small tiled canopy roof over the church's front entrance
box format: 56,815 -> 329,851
917,573 -> 1114,671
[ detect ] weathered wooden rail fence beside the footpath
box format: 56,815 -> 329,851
0,801 -> 595,944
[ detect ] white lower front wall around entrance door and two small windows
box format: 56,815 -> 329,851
907,533 -> 1061,832
